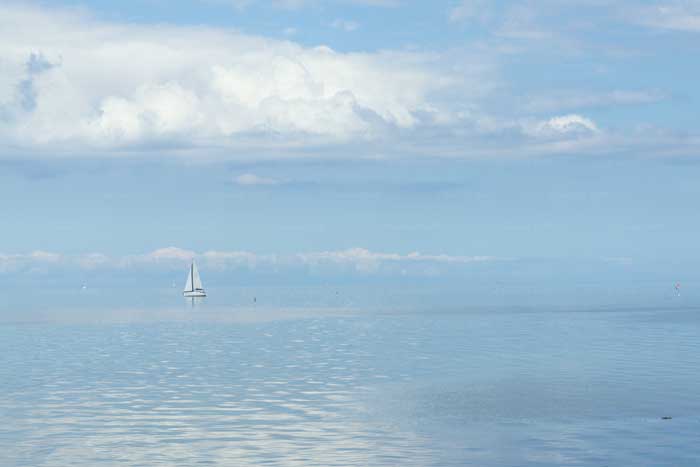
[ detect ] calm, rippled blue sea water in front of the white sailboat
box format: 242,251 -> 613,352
0,304 -> 700,466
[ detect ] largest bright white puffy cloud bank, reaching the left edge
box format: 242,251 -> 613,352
0,5 -> 470,154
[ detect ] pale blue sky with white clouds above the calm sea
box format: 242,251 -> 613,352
0,0 -> 700,296
